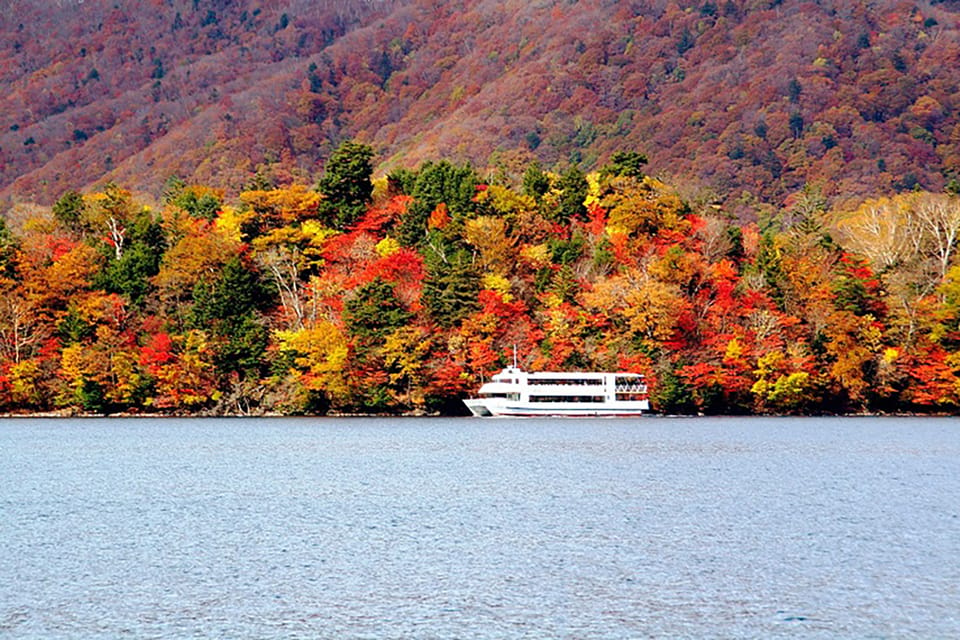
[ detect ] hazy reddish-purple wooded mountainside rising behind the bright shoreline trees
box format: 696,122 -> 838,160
0,0 -> 960,212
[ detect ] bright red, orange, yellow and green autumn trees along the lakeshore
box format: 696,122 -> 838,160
0,141 -> 960,415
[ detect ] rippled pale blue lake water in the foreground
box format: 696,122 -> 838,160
0,418 -> 960,638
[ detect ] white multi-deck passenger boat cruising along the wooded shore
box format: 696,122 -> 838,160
463,366 -> 650,417
